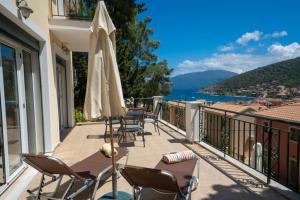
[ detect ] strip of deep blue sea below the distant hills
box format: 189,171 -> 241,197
165,89 -> 254,102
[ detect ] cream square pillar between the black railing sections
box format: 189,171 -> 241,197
185,102 -> 201,142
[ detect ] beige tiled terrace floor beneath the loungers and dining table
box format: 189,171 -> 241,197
0,99 -> 296,200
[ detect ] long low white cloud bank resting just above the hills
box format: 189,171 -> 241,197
172,42 -> 300,76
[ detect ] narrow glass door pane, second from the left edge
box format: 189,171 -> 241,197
23,51 -> 37,153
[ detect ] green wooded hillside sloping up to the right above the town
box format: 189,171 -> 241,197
205,57 -> 300,97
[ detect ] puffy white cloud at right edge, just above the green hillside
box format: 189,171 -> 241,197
268,42 -> 300,58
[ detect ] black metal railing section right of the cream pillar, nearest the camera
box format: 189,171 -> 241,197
199,105 -> 300,193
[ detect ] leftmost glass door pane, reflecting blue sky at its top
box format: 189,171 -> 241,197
1,45 -> 22,174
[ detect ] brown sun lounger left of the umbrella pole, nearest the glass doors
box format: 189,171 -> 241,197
23,148 -> 128,199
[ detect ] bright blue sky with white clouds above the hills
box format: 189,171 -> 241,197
137,0 -> 300,76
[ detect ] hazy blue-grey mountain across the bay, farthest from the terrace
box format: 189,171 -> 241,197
172,70 -> 236,89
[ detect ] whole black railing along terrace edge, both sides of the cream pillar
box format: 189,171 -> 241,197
115,98 -> 300,193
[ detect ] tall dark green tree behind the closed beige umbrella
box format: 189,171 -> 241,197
73,0 -> 171,108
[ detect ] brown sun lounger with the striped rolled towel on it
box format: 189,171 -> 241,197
120,156 -> 200,200
